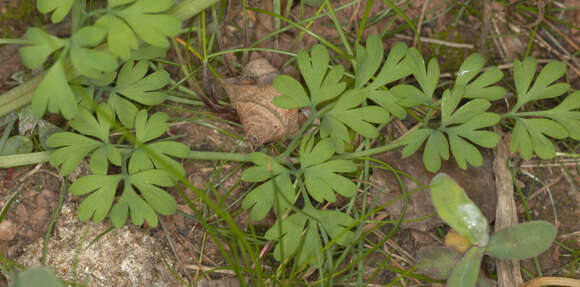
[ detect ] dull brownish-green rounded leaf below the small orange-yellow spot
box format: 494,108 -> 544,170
417,246 -> 461,280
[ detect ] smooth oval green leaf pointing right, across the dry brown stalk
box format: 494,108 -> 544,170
485,221 -> 557,260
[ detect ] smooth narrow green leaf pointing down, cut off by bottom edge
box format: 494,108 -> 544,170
447,246 -> 485,287
